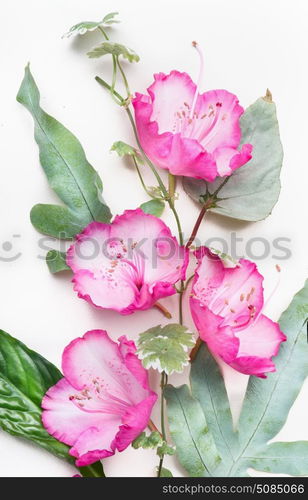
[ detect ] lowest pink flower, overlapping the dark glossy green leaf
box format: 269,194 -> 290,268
42,330 -> 157,467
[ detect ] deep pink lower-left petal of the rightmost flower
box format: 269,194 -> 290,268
190,298 -> 240,364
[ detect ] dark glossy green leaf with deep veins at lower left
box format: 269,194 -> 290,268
0,330 -> 104,477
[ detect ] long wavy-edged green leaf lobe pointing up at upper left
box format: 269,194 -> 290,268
17,65 -> 111,238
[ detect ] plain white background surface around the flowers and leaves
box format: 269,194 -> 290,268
0,0 -> 308,476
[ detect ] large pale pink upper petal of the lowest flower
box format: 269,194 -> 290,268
62,330 -> 153,405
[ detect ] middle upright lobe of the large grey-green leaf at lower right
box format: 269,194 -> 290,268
190,344 -> 238,467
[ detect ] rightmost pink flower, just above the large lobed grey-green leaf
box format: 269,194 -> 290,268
190,247 -> 286,378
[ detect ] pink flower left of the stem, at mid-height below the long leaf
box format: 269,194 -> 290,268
67,209 -> 188,314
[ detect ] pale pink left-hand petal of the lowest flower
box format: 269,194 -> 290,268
42,378 -> 107,445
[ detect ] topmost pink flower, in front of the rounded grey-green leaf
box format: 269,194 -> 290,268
133,71 -> 252,182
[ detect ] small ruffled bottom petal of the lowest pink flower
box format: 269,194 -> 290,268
69,424 -> 121,467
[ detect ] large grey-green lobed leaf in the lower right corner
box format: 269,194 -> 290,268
165,280 -> 308,477
